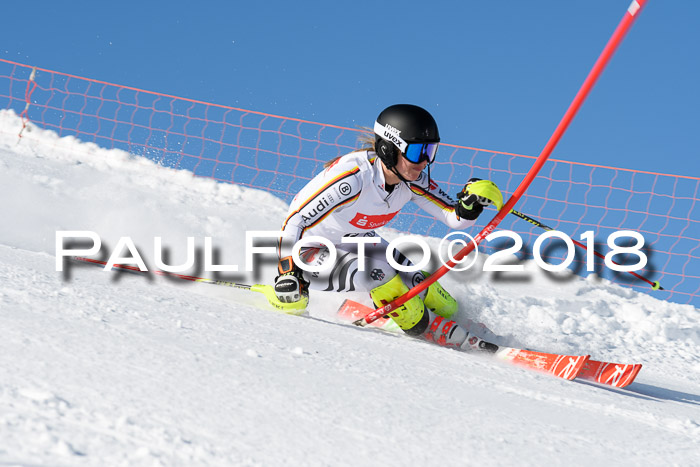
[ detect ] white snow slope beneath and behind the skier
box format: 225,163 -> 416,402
0,111 -> 700,466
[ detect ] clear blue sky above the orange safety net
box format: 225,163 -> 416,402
0,0 -> 700,177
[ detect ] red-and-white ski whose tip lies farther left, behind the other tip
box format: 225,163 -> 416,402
338,300 -> 590,380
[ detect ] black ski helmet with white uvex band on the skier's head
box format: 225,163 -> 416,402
374,104 -> 440,169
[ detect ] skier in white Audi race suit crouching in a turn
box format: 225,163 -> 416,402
275,104 -> 502,350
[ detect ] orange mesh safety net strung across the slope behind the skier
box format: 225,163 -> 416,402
0,59 -> 700,306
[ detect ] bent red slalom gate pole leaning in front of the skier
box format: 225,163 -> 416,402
354,0 -> 647,326
